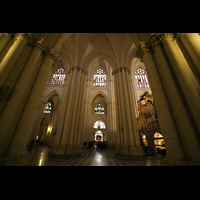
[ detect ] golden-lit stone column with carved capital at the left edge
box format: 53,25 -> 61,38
0,33 -> 28,86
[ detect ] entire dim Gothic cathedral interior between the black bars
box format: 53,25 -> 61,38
0,33 -> 200,166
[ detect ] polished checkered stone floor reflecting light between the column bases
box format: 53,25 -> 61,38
30,145 -> 160,166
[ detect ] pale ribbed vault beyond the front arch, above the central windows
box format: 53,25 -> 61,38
59,33 -> 136,70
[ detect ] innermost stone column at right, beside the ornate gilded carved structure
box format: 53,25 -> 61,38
137,40 -> 187,165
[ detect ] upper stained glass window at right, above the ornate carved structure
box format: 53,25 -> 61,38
135,67 -> 149,89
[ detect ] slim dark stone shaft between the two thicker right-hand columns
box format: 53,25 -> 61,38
154,39 -> 198,164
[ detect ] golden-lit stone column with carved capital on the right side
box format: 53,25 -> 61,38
161,34 -> 200,138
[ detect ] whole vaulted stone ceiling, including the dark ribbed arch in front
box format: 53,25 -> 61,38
27,33 -> 151,71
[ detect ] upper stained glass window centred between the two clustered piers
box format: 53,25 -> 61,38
93,68 -> 106,87
